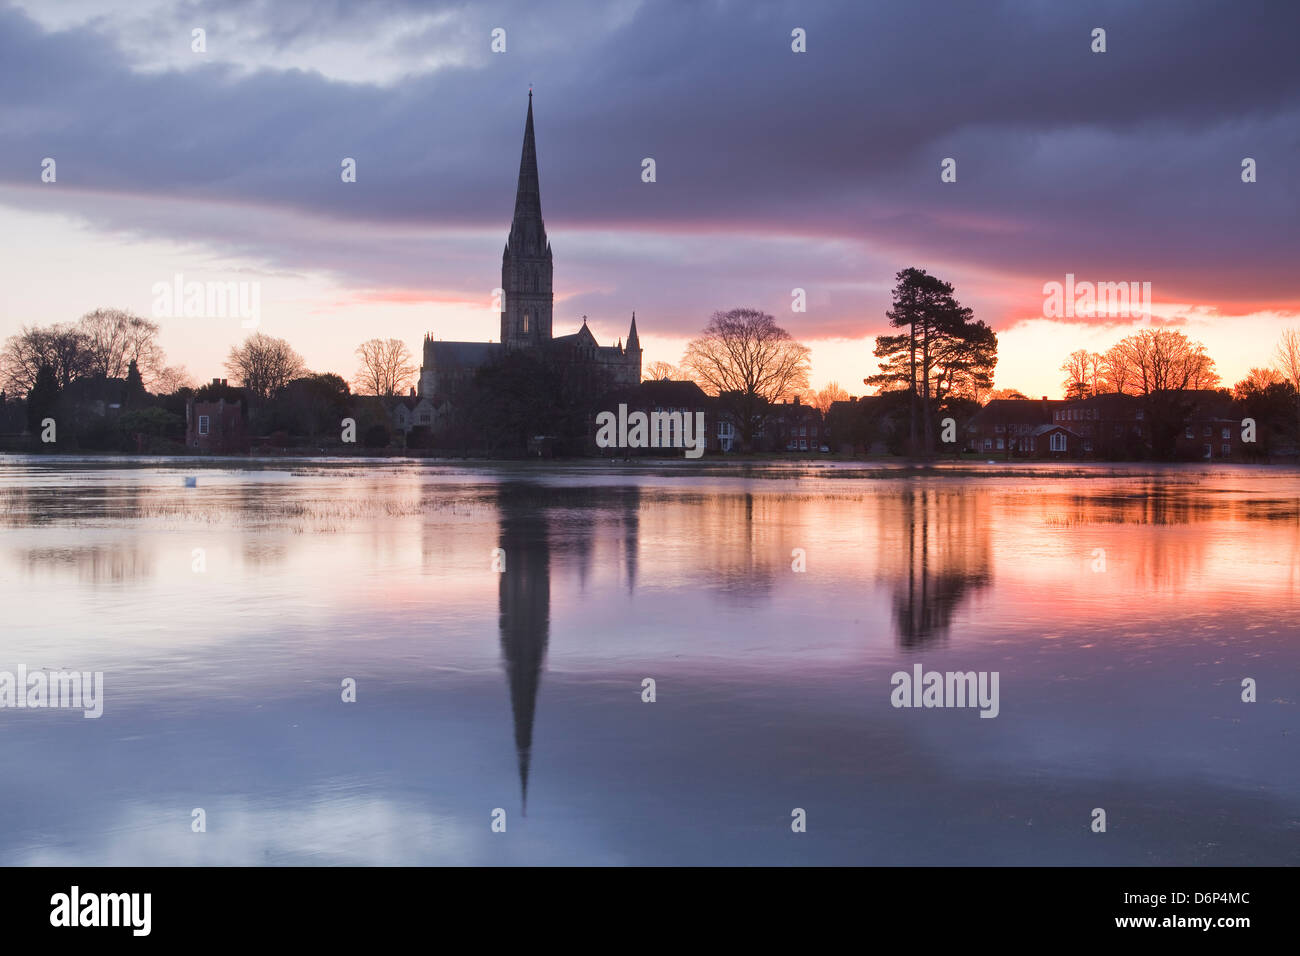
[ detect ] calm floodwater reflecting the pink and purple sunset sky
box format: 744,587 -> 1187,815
0,457 -> 1300,865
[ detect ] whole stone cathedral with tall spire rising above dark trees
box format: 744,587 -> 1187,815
420,90 -> 641,406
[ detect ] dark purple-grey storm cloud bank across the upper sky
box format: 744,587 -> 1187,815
0,0 -> 1300,338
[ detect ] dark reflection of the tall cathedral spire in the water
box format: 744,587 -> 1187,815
498,485 -> 551,816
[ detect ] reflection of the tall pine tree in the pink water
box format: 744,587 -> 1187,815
880,488 -> 992,648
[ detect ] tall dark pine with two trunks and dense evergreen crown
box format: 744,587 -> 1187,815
863,268 -> 997,454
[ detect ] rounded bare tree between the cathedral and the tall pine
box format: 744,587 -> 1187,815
681,308 -> 811,450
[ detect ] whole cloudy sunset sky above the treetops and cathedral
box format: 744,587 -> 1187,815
0,0 -> 1300,397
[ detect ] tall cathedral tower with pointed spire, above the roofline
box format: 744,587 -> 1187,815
501,90 -> 554,350
